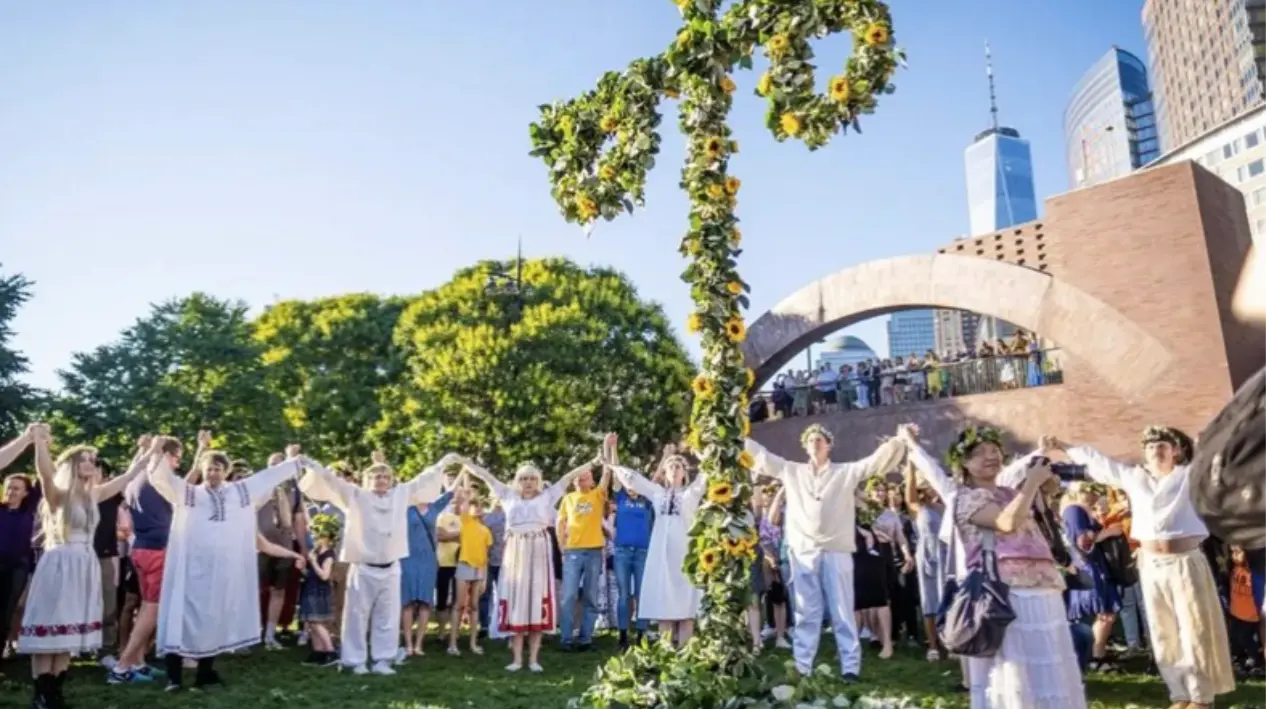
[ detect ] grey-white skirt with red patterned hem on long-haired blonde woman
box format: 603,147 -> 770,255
18,541 -> 101,655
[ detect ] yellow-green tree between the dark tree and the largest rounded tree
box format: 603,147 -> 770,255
254,294 -> 408,461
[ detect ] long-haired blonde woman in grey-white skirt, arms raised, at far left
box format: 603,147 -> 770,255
18,424 -> 156,709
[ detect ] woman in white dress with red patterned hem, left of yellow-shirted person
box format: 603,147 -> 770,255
462,457 -> 601,672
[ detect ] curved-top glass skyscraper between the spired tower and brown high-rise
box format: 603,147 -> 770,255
1063,47 -> 1161,187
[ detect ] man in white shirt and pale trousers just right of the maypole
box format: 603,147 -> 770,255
746,424 -> 906,681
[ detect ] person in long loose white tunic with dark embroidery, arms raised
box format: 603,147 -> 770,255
149,437 -> 301,690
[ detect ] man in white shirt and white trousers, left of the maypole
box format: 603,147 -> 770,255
299,452 -> 458,675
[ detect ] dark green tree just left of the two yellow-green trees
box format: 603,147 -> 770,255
52,294 -> 287,467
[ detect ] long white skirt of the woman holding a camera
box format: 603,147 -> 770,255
967,589 -> 1086,709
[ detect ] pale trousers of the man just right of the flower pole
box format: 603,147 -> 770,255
787,551 -> 862,675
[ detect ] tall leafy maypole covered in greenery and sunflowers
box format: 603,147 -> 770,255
530,0 -> 904,708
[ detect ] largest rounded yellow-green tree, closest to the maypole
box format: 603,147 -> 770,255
373,260 -> 693,476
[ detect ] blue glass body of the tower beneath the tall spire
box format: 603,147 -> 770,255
965,128 -> 1037,237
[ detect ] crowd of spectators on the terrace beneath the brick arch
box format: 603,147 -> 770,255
768,330 -> 1058,418
